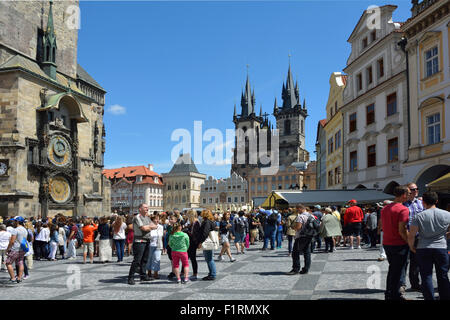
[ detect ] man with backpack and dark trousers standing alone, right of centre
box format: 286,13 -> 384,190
287,205 -> 317,275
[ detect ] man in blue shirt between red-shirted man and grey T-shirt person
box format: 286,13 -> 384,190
402,182 -> 424,291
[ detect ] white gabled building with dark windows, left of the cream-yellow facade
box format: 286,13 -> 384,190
342,5 -> 408,192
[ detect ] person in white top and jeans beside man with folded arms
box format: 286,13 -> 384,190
147,213 -> 164,279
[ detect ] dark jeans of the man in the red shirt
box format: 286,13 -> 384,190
384,245 -> 409,300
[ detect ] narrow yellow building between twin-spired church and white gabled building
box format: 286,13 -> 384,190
324,72 -> 347,189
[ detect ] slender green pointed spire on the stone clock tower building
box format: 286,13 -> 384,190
42,0 -> 57,80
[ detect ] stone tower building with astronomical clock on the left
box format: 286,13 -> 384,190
0,1 -> 110,217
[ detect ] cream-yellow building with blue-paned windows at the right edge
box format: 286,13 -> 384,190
402,0 -> 450,193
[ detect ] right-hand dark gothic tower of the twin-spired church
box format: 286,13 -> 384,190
273,64 -> 309,166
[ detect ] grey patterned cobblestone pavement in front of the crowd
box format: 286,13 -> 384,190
0,241 -> 436,300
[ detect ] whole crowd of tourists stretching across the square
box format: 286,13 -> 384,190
0,183 -> 450,299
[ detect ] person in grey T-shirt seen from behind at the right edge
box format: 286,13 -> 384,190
408,189 -> 450,300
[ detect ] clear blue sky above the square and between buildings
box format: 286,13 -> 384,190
78,0 -> 411,178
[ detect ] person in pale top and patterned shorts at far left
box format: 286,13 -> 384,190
6,217 -> 28,283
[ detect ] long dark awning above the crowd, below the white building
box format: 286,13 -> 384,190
262,189 -> 394,208
